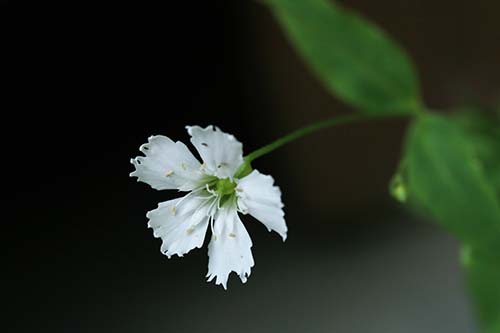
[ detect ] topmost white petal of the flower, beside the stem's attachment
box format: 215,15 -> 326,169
186,126 -> 243,178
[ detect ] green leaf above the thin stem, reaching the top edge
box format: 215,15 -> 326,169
266,0 -> 421,113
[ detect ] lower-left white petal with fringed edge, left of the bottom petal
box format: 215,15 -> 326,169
146,192 -> 215,258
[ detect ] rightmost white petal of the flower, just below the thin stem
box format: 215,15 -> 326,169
236,170 -> 288,241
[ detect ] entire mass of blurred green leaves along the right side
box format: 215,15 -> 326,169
266,0 -> 500,333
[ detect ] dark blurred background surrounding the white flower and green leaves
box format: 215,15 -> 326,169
8,0 -> 500,333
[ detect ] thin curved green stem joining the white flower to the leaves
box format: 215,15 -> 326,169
245,113 -> 408,164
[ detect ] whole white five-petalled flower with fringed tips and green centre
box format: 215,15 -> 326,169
130,126 -> 287,289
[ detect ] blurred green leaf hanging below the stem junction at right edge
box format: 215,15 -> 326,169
406,115 -> 500,249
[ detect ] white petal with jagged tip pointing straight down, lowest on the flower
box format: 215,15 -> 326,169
207,205 -> 254,289
